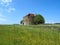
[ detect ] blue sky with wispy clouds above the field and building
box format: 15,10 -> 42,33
0,0 -> 60,24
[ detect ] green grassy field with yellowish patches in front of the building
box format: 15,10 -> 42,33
0,25 -> 60,45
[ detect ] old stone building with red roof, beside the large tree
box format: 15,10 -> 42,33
23,14 -> 34,25
